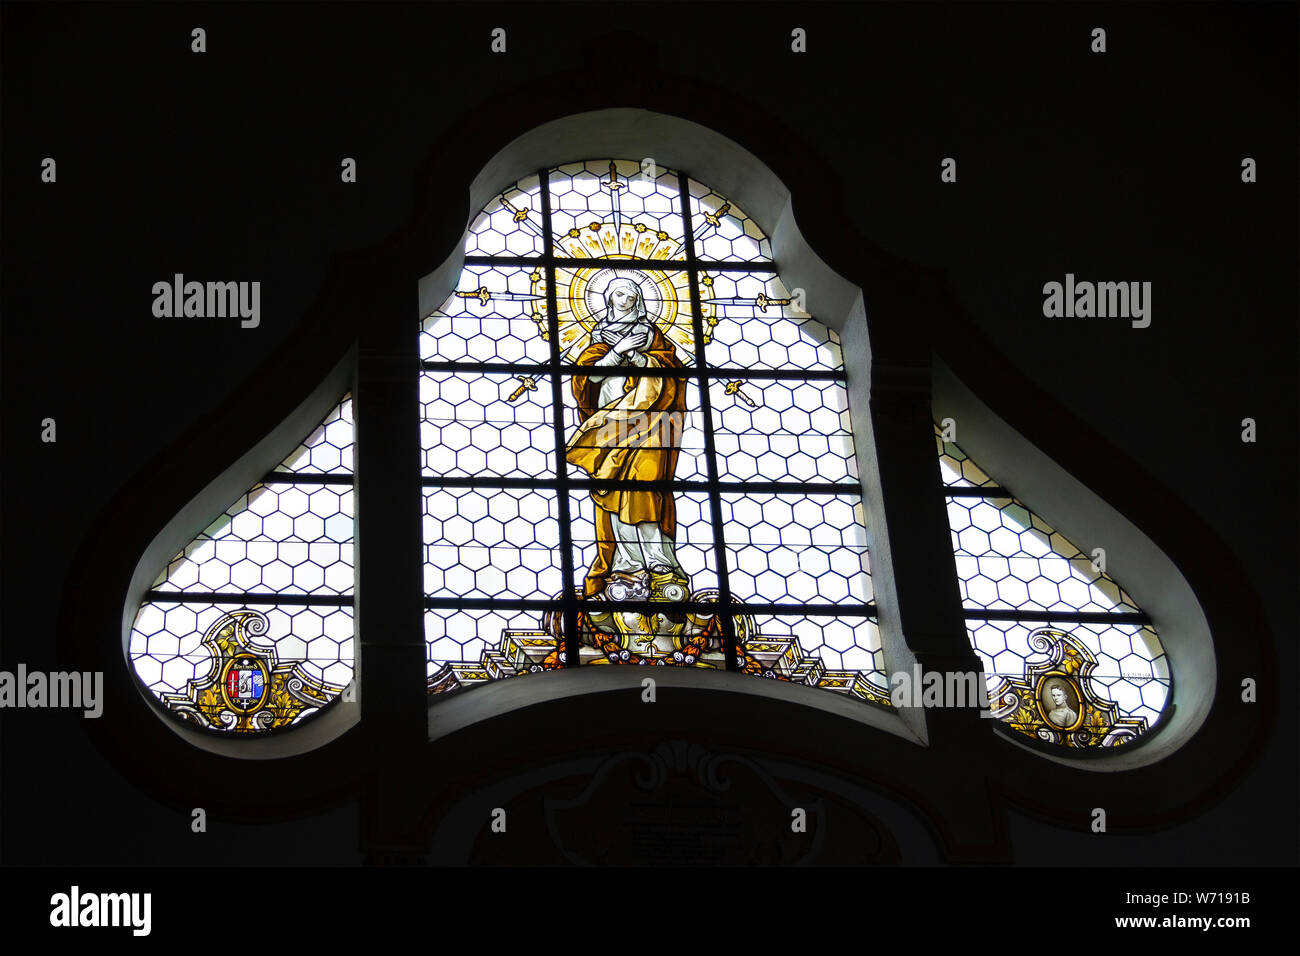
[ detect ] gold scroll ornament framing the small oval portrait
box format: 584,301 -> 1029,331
989,628 -> 1147,748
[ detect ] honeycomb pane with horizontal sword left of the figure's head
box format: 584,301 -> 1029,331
420,265 -> 551,364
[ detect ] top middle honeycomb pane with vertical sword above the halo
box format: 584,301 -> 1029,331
550,160 -> 685,259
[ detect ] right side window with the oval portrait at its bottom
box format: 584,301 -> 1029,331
935,425 -> 1170,748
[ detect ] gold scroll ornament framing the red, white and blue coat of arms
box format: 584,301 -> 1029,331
163,609 -> 343,732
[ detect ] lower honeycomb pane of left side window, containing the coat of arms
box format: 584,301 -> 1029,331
127,601 -> 355,734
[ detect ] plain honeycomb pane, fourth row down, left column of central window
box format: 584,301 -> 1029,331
424,488 -> 563,600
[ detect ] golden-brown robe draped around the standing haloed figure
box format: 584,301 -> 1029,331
566,329 -> 686,597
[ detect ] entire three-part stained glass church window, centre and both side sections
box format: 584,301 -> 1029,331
127,159 -> 1190,748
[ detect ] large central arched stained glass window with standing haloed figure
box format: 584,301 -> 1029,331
420,159 -> 889,706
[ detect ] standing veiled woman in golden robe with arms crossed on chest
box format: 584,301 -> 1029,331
566,277 -> 686,600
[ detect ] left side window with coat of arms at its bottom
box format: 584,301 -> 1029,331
129,395 -> 354,734
